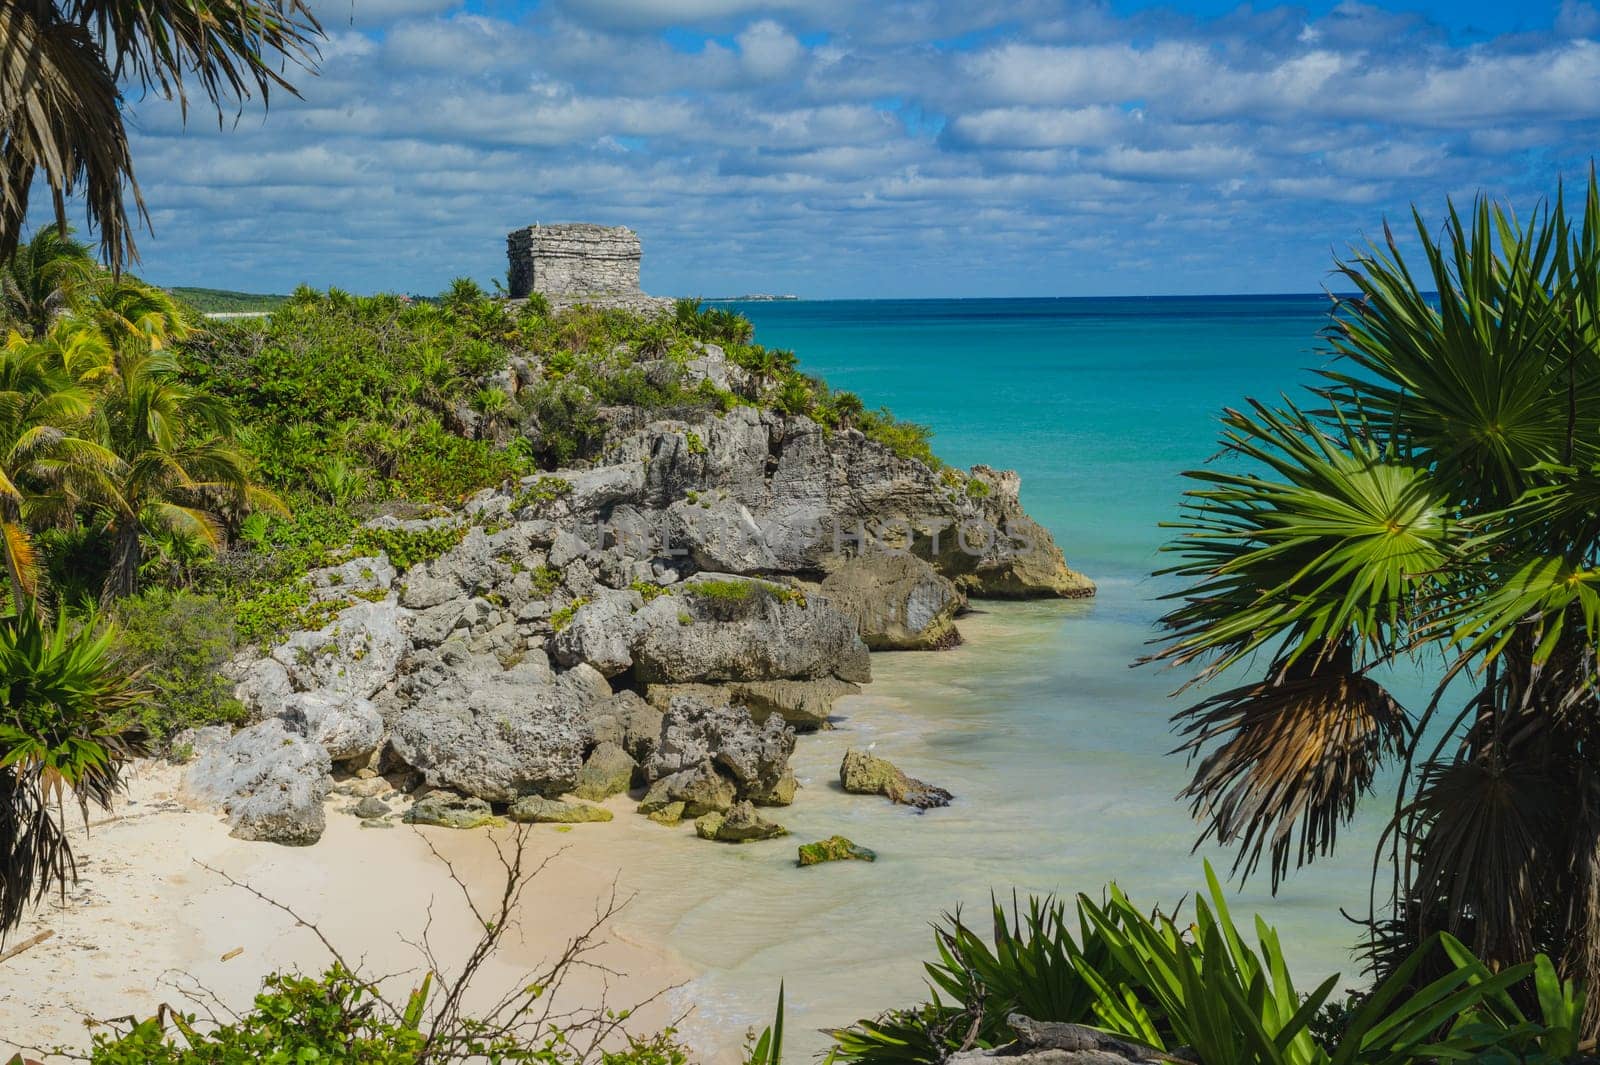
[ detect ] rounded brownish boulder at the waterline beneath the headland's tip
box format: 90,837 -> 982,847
821,550 -> 966,651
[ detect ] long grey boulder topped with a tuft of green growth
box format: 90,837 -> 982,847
634,574 -> 872,683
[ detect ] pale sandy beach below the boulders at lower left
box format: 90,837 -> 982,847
0,763 -> 688,1062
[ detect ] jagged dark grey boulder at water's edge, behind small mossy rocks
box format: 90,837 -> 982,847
643,696 -> 795,806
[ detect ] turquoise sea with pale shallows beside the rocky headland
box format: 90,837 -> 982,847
588,296 -> 1419,1051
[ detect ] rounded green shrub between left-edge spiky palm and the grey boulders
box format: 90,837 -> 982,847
109,587 -> 245,742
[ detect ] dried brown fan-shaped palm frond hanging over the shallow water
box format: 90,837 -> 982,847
1178,664 -> 1410,891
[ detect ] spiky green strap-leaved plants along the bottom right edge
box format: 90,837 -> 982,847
832,867 -> 1582,1065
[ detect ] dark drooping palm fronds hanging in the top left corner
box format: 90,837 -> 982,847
0,0 -> 322,269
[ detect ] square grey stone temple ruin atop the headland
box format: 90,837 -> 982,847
506,222 -> 672,313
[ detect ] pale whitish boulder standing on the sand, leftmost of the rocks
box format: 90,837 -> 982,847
184,718 -> 333,846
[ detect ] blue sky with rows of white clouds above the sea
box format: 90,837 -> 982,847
93,0 -> 1600,297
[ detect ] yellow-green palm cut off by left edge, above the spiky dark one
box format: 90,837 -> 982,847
0,344 -> 115,608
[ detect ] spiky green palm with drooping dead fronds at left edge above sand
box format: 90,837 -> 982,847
0,611 -> 142,935
